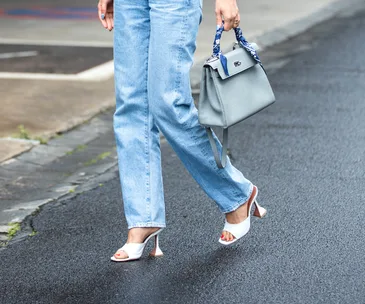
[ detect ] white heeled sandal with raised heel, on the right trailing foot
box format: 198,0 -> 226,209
219,186 -> 267,245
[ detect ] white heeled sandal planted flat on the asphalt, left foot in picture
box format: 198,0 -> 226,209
110,228 -> 163,262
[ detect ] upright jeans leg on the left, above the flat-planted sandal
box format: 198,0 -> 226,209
114,0 -> 165,229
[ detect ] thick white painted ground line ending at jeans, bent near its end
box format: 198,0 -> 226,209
0,60 -> 114,81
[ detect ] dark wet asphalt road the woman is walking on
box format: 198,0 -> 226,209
0,8 -> 365,304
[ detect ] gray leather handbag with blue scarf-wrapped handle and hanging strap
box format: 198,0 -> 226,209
198,24 -> 275,168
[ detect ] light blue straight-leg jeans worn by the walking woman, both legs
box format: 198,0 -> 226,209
114,0 -> 253,229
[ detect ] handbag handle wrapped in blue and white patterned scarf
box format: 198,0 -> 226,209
212,21 -> 262,76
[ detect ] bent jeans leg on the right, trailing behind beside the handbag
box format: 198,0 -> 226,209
148,0 -> 253,213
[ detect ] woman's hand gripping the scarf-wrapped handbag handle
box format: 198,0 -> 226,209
215,0 -> 241,31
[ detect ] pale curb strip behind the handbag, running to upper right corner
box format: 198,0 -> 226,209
190,0 -> 365,90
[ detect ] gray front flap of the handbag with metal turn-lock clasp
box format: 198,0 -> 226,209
204,47 -> 257,79
